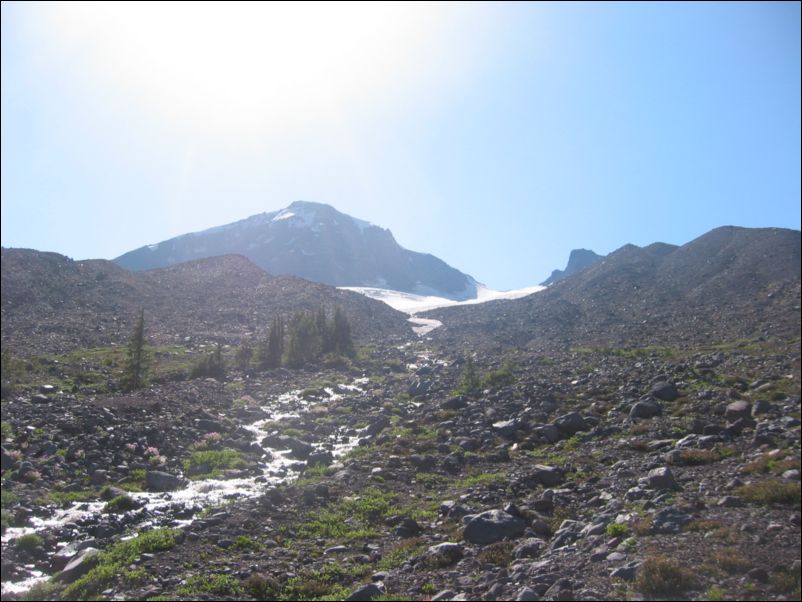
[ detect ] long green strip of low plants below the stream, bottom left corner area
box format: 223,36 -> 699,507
63,529 -> 181,600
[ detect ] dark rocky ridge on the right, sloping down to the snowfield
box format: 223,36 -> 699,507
422,226 -> 800,347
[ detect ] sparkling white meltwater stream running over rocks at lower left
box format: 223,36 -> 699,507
2,378 -> 368,594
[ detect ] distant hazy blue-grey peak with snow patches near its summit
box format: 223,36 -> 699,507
114,201 -> 476,300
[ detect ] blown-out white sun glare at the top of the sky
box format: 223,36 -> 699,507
39,2 -> 436,133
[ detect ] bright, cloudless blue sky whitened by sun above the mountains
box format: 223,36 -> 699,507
1,2 -> 801,289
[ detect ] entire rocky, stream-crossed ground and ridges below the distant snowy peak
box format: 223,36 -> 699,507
2,224 -> 802,600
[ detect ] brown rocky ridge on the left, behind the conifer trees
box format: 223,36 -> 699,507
2,248 -> 410,355
